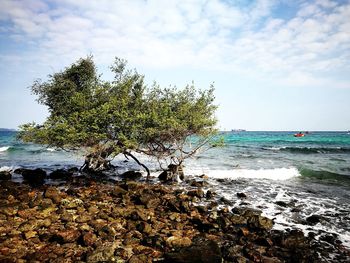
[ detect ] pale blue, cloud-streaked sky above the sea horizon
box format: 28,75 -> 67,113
0,0 -> 350,131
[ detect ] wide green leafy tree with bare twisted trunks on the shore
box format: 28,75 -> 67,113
18,57 -> 217,182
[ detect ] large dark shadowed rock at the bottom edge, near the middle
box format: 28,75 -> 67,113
164,238 -> 222,263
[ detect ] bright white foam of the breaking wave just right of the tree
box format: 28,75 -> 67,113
187,167 -> 300,180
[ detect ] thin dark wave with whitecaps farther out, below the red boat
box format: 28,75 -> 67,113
261,146 -> 350,154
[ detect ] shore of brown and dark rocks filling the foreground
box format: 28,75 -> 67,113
0,170 -> 350,263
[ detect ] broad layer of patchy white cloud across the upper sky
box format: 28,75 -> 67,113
0,0 -> 350,89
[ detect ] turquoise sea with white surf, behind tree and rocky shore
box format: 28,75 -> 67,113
0,131 -> 350,248
